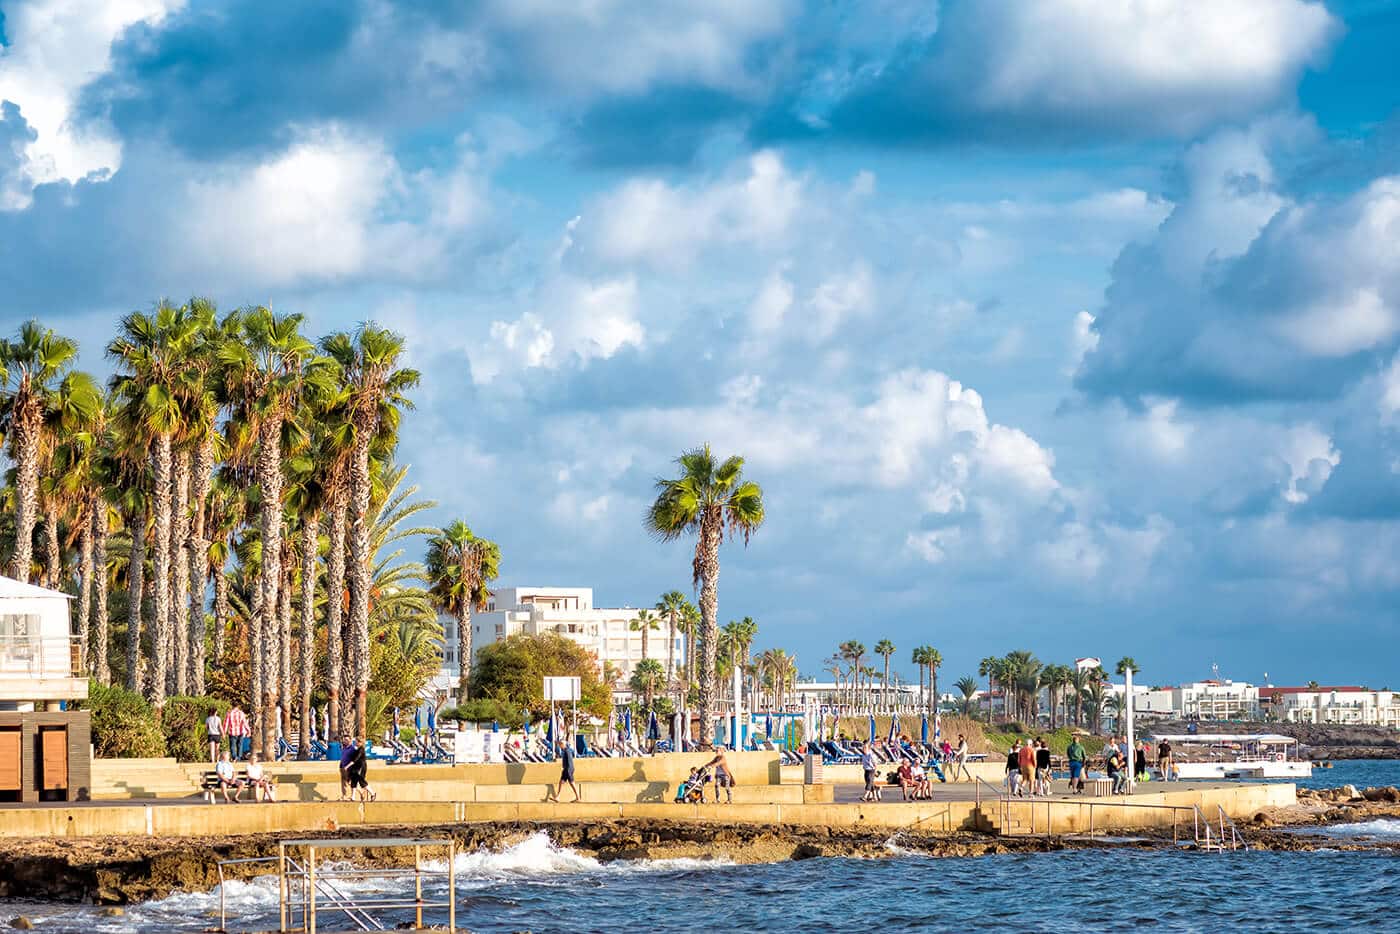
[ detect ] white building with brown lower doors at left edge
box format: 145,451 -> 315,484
0,577 -> 91,801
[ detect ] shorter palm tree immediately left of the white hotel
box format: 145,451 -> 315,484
426,520 -> 504,703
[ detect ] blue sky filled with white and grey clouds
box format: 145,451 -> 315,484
0,0 -> 1400,686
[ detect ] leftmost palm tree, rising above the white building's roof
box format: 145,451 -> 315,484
0,321 -> 97,583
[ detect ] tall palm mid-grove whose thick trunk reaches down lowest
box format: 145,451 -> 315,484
218,305 -> 328,755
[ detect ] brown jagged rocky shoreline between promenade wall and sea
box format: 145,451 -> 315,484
0,787 -> 1400,905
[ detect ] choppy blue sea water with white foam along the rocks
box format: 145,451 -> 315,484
0,762 -> 1400,934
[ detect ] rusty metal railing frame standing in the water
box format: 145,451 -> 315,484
218,837 -> 456,934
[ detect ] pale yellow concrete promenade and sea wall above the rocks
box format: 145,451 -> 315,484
0,752 -> 1295,837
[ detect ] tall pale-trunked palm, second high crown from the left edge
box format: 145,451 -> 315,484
106,301 -> 197,711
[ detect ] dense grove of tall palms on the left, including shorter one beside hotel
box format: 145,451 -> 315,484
0,310 -> 500,752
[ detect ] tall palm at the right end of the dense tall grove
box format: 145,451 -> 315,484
322,323 -> 414,735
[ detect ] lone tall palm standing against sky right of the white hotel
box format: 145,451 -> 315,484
645,444 -> 763,745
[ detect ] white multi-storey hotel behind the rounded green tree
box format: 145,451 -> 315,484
435,587 -> 685,693
